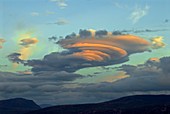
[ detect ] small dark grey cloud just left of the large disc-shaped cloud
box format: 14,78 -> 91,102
7,53 -> 24,64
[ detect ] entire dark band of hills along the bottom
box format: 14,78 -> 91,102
0,95 -> 170,114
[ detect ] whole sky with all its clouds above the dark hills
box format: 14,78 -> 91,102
0,0 -> 170,105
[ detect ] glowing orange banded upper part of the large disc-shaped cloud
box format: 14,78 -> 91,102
59,31 -> 151,61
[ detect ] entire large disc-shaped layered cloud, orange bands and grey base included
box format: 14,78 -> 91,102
24,30 -> 152,72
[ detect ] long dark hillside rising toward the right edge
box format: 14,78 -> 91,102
26,95 -> 170,114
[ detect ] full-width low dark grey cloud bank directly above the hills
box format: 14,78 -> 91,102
0,56 -> 170,105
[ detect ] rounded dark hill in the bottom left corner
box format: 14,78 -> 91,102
0,98 -> 40,114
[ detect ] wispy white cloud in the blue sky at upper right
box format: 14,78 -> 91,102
130,5 -> 149,24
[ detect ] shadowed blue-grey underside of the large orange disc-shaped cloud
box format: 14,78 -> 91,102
25,50 -> 128,72
